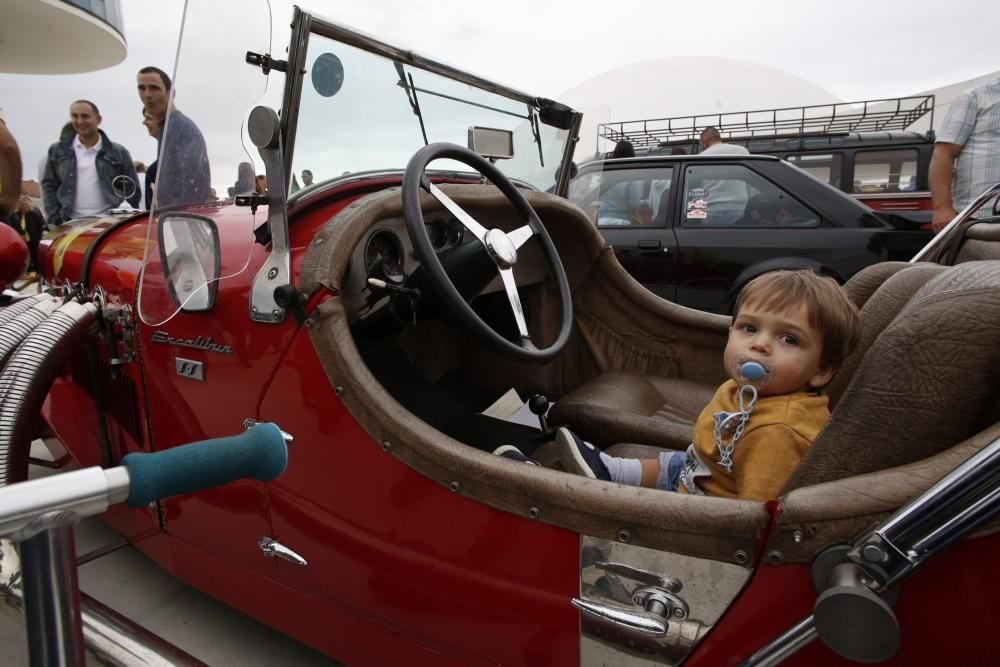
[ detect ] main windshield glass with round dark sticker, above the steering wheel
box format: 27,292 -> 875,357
290,29 -> 569,196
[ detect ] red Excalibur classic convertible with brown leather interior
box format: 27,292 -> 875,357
0,2 -> 1000,666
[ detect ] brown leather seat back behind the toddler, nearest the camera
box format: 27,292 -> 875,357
784,260 -> 1000,492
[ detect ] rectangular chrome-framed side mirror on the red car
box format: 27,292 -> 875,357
159,215 -> 221,313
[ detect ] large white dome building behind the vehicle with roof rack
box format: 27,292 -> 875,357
557,56 -> 842,161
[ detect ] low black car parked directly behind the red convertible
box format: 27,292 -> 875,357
568,155 -> 931,314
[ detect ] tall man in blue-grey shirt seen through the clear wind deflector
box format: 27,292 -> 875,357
137,67 -> 212,208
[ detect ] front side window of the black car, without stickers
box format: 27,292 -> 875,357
568,166 -> 674,227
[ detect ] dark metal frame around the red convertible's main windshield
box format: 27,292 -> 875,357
281,7 -> 583,201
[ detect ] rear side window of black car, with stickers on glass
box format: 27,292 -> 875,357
681,164 -> 820,227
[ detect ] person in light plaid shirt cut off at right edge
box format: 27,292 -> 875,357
928,76 -> 1000,232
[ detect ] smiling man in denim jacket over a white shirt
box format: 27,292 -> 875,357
42,100 -> 141,226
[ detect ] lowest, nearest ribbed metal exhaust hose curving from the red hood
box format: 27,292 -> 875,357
0,301 -> 97,486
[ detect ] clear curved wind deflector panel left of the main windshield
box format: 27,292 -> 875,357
137,0 -> 271,326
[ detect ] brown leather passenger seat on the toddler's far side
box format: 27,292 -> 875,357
549,262 -> 946,448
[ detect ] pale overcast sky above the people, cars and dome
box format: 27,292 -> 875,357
0,0 -> 1000,188
